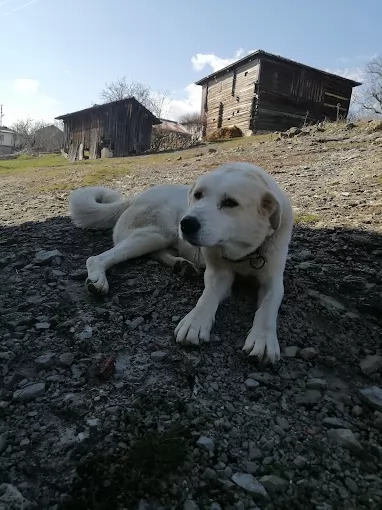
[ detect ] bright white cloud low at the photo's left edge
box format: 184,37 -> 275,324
0,78 -> 62,126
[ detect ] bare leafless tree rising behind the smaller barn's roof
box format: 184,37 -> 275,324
100,77 -> 171,118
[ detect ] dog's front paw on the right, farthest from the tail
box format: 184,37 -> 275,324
243,324 -> 280,363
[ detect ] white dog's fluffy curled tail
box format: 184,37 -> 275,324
69,186 -> 131,229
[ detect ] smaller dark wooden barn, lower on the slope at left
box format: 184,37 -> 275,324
57,97 -> 160,161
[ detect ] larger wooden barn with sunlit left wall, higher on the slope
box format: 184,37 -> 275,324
196,50 -> 361,136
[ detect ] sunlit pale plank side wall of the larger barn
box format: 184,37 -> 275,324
202,60 -> 259,135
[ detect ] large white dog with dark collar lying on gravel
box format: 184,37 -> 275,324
69,163 -> 293,362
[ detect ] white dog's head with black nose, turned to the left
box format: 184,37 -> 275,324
179,163 -> 281,259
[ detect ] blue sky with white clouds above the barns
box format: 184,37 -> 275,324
0,0 -> 382,126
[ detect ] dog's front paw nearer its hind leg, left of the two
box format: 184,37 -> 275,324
175,308 -> 213,345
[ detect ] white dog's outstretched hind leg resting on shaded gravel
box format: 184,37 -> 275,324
85,227 -> 171,295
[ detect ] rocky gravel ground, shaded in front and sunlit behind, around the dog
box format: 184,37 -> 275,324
0,120 -> 382,510
